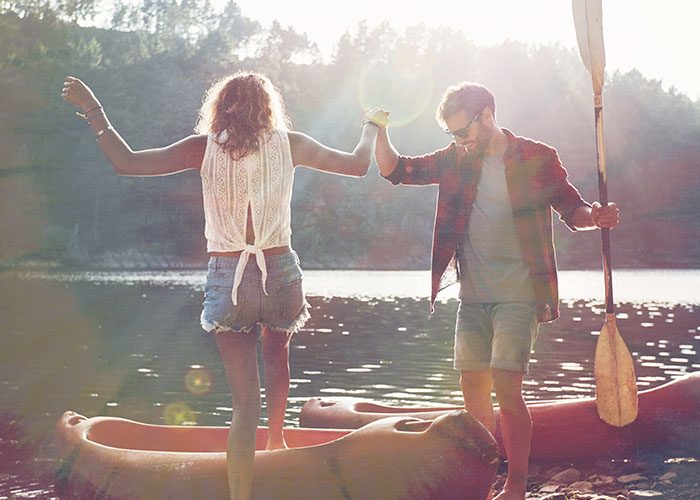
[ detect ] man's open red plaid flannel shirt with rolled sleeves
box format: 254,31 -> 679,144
386,129 -> 590,322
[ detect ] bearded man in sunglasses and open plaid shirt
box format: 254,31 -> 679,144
371,82 -> 619,500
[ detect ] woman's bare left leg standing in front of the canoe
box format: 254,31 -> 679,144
214,332 -> 260,500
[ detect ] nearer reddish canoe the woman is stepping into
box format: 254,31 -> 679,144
56,411 -> 498,500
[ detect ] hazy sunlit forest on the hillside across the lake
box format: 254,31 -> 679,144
0,0 -> 700,270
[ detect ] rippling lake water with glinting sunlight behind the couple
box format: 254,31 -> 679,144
0,270 -> 700,499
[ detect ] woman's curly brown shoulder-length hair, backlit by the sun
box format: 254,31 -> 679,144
195,72 -> 290,160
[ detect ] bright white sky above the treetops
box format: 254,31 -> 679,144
230,0 -> 700,100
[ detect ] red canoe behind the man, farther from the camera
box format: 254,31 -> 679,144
299,372 -> 700,462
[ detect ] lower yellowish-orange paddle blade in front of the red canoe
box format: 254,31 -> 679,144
594,314 -> 637,427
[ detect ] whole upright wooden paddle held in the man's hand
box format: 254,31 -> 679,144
572,0 -> 637,427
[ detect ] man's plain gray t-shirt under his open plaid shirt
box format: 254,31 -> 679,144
459,152 -> 535,303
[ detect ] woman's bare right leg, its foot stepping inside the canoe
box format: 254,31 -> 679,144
262,326 -> 292,450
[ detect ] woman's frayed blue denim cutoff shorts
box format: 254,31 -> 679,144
200,250 -> 310,333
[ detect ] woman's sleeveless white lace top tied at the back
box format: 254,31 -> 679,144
200,130 -> 294,304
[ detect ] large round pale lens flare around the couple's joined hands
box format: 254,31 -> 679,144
358,53 -> 434,127
